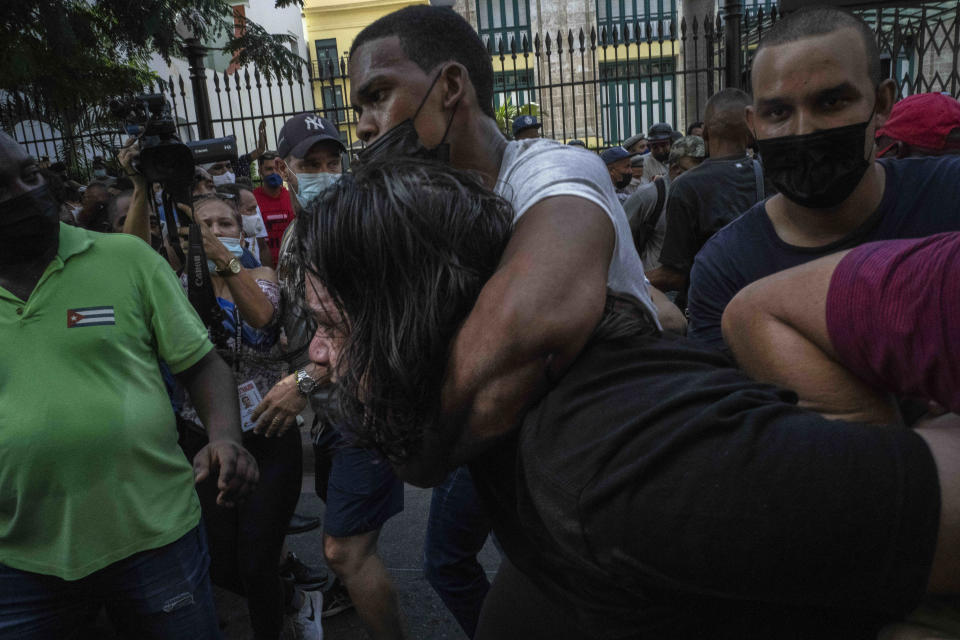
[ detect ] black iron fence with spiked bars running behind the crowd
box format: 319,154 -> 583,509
0,0 -> 960,176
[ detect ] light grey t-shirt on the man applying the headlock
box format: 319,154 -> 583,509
496,138 -> 659,326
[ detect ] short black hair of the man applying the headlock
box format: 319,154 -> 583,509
350,5 -> 495,118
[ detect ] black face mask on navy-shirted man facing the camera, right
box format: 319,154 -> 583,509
757,112 -> 873,209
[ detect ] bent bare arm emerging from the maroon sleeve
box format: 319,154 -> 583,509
723,253 -> 899,423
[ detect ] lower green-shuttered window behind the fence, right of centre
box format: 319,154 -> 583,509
599,59 -> 677,144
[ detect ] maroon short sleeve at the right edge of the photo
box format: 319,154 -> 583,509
827,233 -> 960,412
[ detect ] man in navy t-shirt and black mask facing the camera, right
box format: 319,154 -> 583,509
688,8 -> 960,349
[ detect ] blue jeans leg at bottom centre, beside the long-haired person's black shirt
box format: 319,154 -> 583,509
423,467 -> 491,638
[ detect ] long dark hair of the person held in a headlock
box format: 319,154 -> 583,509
295,159 -> 513,462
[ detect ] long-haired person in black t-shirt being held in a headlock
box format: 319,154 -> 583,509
297,159 -> 960,640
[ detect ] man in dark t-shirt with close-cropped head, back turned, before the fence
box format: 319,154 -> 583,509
647,89 -> 764,292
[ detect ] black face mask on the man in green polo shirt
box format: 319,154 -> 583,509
0,185 -> 60,264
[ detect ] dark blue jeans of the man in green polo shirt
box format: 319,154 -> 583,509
0,526 -> 220,640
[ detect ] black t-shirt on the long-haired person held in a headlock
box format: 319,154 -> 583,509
472,337 -> 940,638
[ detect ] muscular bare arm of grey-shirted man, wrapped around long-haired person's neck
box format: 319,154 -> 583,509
397,196 -> 616,486
